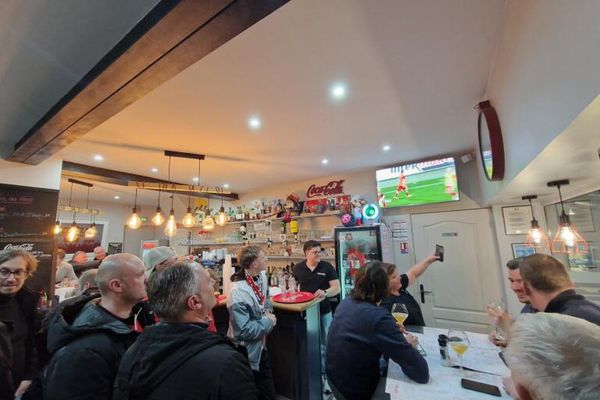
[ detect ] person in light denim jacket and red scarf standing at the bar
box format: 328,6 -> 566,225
227,246 -> 277,400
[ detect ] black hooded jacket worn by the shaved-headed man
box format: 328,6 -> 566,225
43,298 -> 137,400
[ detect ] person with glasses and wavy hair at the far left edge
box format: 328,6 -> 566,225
0,250 -> 38,398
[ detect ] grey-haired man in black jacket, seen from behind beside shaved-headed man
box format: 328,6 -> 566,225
114,262 -> 258,400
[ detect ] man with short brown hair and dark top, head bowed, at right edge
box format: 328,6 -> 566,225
519,254 -> 600,325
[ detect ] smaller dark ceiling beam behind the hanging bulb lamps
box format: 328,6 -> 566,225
62,161 -> 239,200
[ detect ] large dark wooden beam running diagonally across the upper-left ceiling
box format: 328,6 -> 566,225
7,0 -> 289,165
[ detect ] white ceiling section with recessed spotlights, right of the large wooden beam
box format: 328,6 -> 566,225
52,0 -> 505,197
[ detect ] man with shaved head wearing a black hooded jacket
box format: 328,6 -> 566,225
44,254 -> 146,400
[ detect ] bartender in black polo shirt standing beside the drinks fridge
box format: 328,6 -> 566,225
292,240 -> 340,382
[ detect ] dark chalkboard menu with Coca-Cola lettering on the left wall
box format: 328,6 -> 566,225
0,184 -> 58,295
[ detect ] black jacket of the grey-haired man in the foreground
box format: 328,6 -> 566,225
114,323 -> 258,400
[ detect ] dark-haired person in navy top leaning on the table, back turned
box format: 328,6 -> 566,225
327,261 -> 429,400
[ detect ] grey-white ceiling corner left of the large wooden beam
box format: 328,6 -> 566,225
0,0 -> 158,157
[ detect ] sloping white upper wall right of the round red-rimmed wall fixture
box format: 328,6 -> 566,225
480,0 -> 600,202
